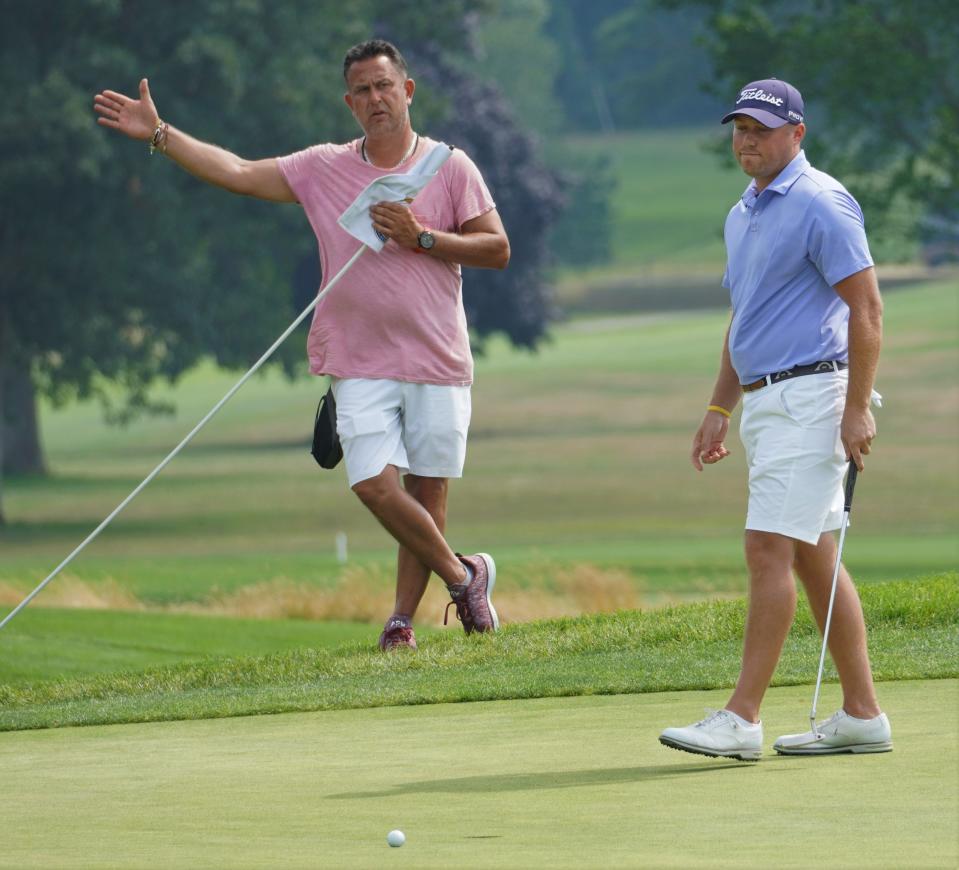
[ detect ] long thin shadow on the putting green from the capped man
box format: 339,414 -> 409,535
327,759 -> 756,800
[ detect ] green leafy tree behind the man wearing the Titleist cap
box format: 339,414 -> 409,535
660,0 -> 959,242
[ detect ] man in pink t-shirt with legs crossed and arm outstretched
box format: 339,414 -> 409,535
94,40 -> 510,650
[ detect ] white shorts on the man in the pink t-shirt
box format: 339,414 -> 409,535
332,378 -> 471,486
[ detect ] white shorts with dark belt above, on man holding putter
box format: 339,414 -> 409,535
739,371 -> 849,544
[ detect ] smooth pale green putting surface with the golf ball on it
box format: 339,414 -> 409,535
0,680 -> 959,868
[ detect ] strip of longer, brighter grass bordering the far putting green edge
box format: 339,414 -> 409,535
0,574 -> 959,730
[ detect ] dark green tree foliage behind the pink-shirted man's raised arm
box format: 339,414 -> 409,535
0,0 -> 564,521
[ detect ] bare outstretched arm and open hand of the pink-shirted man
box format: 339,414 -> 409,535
93,79 -> 296,202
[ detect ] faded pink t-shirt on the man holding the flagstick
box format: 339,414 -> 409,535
278,137 -> 496,386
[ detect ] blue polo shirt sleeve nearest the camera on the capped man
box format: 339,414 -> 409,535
806,190 -> 873,287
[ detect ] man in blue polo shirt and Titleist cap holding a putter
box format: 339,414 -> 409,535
660,79 -> 892,760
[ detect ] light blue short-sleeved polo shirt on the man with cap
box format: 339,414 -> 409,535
723,151 -> 873,384
